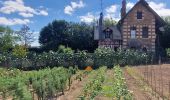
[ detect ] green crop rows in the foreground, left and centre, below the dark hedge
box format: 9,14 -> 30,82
0,66 -> 135,100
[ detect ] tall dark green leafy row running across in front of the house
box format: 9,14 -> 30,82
0,48 -> 152,69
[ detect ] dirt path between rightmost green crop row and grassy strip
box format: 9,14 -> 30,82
124,70 -> 150,100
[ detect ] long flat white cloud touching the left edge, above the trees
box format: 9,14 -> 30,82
0,17 -> 30,25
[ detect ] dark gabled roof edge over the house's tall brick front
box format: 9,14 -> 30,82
118,0 -> 165,25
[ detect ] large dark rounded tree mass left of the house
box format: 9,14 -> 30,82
39,20 -> 97,51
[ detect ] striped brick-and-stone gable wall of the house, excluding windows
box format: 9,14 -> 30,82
122,4 -> 156,52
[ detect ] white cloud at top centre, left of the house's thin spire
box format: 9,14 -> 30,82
64,0 -> 85,15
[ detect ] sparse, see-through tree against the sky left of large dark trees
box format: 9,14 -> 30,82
17,25 -> 34,47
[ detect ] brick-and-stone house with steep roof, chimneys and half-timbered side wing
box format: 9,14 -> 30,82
94,0 -> 165,52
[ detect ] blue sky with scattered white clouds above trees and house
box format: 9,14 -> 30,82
0,0 -> 170,46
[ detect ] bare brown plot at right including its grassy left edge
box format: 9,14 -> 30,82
127,64 -> 170,100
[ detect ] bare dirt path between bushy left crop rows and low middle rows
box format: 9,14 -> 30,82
57,76 -> 88,100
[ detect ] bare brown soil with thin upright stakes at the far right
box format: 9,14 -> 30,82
136,64 -> 170,99
